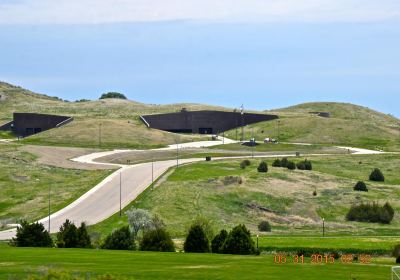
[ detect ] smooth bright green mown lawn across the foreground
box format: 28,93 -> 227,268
0,246 -> 393,280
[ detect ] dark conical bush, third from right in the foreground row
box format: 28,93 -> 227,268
184,225 -> 210,253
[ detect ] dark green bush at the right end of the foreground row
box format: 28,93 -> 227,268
222,225 -> 256,255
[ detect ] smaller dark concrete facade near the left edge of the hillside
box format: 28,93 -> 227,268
1,113 -> 73,137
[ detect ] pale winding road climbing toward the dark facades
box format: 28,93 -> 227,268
0,139 -> 388,240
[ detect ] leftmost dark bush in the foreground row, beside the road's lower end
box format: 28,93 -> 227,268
10,221 -> 53,247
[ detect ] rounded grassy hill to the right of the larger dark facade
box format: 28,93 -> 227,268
230,102 -> 400,150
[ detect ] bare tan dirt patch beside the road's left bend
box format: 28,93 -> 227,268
20,145 -> 116,170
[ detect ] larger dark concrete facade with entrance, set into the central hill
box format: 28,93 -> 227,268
141,110 -> 278,134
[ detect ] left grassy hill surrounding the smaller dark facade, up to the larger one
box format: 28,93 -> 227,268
0,83 -> 226,148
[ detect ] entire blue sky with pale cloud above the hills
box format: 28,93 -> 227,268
0,0 -> 400,117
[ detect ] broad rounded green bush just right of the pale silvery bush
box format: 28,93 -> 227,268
140,228 -> 175,252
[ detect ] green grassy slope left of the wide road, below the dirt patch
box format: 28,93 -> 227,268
0,144 -> 110,223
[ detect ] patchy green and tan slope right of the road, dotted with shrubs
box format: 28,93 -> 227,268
93,155 -> 400,238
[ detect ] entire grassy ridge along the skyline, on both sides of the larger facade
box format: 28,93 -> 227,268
0,82 -> 400,150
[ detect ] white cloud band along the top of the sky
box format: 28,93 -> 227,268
0,0 -> 400,24
